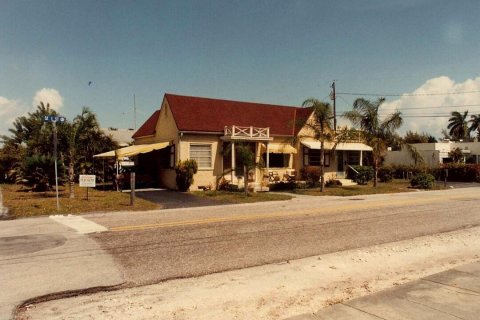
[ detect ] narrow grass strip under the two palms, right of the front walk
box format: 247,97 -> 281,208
286,180 -> 443,197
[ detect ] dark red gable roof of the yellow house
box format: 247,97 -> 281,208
133,93 -> 312,138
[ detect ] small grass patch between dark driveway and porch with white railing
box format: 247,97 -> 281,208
192,191 -> 292,203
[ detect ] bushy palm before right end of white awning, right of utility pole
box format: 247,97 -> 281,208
344,98 -> 403,187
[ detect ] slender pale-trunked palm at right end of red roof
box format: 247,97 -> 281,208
299,98 -> 350,192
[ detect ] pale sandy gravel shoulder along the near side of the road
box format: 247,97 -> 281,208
18,227 -> 480,320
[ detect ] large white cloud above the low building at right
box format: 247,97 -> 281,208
381,76 -> 480,138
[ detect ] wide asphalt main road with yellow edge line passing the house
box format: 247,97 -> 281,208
87,188 -> 480,285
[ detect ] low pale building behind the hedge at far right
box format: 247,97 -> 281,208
385,140 -> 480,167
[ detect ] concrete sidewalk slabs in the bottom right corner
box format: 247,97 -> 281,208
286,262 -> 480,320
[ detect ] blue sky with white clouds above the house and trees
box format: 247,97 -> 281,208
0,0 -> 480,137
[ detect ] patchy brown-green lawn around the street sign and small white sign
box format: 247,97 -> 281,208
1,184 -> 158,218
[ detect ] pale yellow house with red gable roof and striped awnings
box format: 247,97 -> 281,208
97,93 -> 372,190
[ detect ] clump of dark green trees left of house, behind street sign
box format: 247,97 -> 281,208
0,102 -> 115,192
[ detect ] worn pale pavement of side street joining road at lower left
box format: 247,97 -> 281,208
0,217 -> 123,320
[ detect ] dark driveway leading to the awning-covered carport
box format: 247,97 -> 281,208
135,189 -> 227,209
